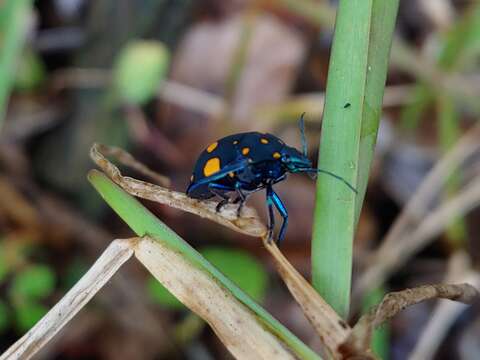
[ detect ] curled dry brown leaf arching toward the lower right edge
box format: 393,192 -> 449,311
341,284 -> 479,354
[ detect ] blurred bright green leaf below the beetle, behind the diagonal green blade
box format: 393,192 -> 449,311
200,247 -> 268,302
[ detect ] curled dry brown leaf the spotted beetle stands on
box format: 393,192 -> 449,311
90,144 -> 267,237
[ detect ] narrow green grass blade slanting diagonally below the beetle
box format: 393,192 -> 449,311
88,170 -> 320,359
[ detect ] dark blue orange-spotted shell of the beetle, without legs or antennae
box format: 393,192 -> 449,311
187,132 -> 285,199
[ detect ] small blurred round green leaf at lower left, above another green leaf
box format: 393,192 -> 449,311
10,265 -> 55,302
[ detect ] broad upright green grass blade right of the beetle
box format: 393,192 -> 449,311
312,0 -> 398,317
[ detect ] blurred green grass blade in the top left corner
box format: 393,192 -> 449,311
0,0 -> 32,128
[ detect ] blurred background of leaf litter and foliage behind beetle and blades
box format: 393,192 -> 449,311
0,0 -> 480,359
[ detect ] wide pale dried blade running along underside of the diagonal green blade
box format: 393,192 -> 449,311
135,237 -> 294,360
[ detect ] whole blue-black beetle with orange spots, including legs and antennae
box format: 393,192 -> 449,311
187,114 -> 356,243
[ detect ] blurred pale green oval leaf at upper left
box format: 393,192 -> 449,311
113,41 -> 170,105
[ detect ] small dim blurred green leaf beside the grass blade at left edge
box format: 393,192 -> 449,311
15,50 -> 45,92
